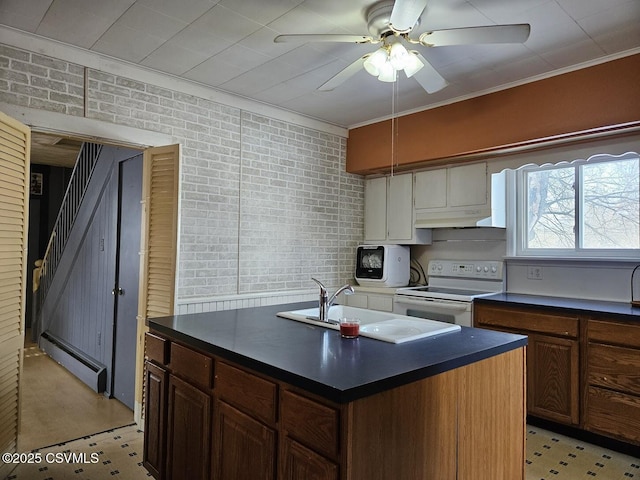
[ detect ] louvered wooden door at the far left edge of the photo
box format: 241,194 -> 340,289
0,112 -> 31,478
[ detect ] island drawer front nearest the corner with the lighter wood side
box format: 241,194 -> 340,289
280,390 -> 340,457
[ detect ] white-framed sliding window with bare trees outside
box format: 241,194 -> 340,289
516,153 -> 640,257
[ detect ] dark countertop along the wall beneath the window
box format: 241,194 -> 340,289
474,293 -> 640,321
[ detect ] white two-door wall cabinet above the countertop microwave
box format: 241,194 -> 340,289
364,173 -> 431,245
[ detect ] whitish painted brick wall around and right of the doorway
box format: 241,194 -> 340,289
0,44 -> 364,312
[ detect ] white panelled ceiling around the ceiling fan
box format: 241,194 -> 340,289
0,0 -> 640,127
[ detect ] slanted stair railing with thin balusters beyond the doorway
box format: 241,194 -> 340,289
37,142 -> 102,316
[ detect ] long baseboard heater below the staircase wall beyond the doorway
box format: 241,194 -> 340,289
40,332 -> 107,393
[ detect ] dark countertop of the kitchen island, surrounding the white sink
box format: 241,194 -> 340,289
147,302 -> 527,403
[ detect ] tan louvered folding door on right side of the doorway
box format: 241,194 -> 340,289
136,145 -> 180,421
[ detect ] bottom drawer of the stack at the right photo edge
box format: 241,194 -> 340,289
585,387 -> 640,444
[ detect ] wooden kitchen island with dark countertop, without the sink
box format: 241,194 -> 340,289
144,303 -> 527,480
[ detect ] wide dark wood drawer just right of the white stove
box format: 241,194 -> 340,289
474,305 -> 579,338
